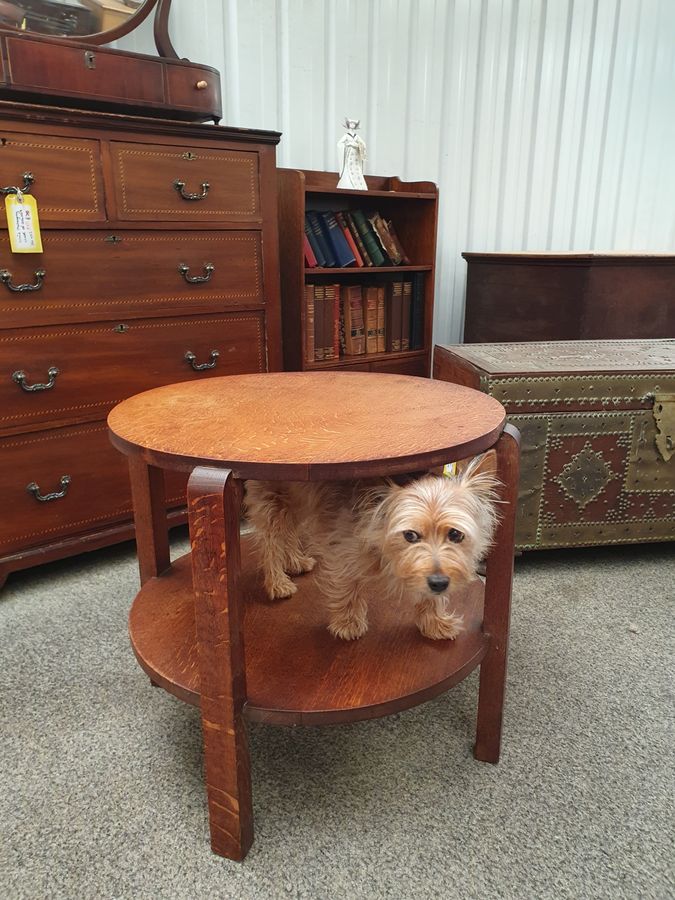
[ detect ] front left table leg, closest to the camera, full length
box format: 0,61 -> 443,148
188,467 -> 253,859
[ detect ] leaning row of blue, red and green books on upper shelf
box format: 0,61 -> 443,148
303,209 -> 410,269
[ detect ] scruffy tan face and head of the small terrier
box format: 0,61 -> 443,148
372,459 -> 497,595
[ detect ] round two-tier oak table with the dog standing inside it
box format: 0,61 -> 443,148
108,372 -> 518,859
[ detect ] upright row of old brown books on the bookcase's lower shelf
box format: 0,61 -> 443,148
305,273 -> 424,363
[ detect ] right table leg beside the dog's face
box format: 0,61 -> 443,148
474,425 -> 520,763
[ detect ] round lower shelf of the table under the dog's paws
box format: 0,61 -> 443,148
129,538 -> 490,725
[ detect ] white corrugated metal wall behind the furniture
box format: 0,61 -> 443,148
124,0 -> 675,342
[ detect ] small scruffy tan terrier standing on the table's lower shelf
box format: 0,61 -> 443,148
245,453 -> 499,640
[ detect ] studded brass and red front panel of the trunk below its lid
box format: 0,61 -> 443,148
500,409 -> 675,550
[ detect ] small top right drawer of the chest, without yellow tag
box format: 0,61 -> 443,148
110,141 -> 260,222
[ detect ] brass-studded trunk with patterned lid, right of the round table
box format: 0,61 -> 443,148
434,340 -> 675,550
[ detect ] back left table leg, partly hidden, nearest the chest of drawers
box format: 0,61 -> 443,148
129,456 -> 171,584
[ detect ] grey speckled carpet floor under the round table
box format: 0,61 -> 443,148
0,534 -> 675,900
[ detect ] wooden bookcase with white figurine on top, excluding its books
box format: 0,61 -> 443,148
277,169 -> 438,377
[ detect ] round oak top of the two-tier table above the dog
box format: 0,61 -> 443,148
108,372 -> 505,481
